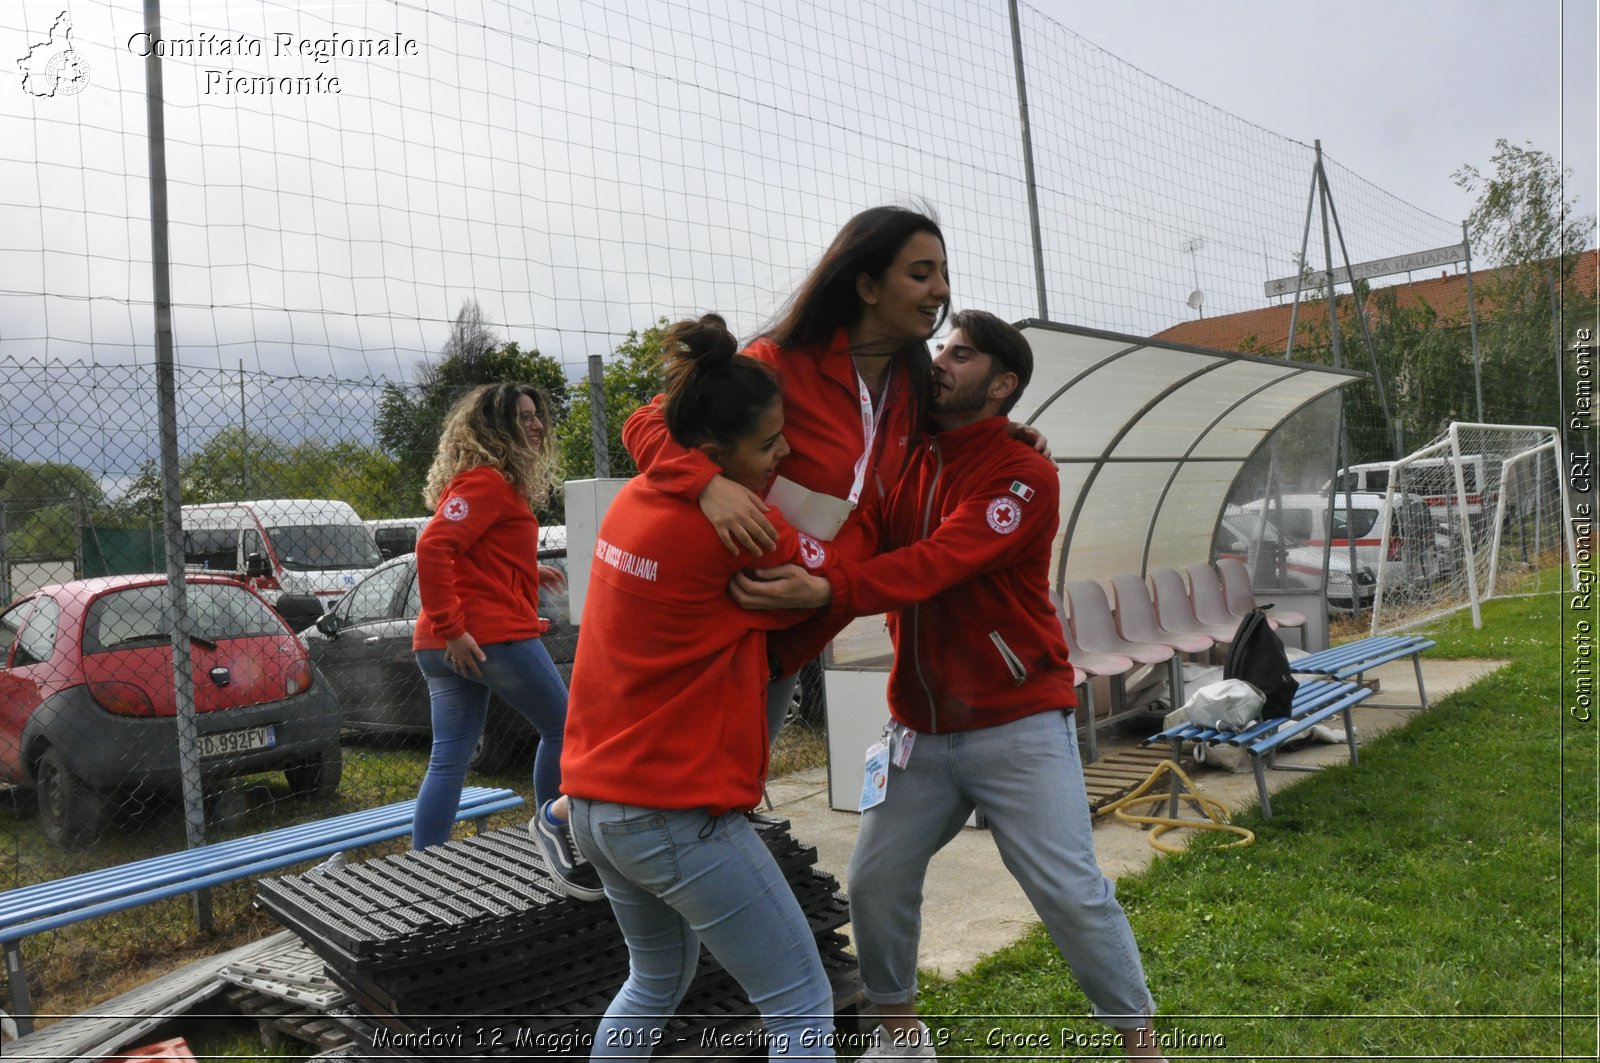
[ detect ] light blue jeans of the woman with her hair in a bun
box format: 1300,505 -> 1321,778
573,797 -> 834,1060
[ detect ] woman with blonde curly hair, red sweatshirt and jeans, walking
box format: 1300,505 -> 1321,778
411,383 -> 603,900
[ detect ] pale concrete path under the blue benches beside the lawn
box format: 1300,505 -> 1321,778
768,655 -> 1506,977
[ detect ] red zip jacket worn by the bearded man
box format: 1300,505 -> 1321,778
773,416 -> 1077,733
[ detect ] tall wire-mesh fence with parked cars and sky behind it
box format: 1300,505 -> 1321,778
0,0 -> 1594,1011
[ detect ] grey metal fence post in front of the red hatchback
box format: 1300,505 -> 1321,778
144,0 -> 211,930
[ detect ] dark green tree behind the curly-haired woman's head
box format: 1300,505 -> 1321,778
374,301 -> 570,520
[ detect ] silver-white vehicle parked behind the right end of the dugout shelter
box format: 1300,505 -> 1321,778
1240,491 -> 1450,592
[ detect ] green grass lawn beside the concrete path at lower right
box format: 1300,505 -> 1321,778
918,596 -> 1600,1060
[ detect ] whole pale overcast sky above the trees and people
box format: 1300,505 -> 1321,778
0,0 -> 1595,466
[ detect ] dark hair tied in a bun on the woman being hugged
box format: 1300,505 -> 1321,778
661,314 -> 779,447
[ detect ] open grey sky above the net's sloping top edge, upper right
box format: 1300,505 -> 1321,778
1034,0 -> 1600,233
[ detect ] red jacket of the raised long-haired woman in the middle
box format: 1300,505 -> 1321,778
622,328 -> 914,528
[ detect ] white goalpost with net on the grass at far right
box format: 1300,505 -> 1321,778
1371,421 -> 1578,634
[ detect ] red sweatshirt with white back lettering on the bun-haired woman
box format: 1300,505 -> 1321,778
562,477 -> 830,815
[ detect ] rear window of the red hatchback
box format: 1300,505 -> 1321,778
83,583 -> 288,653
